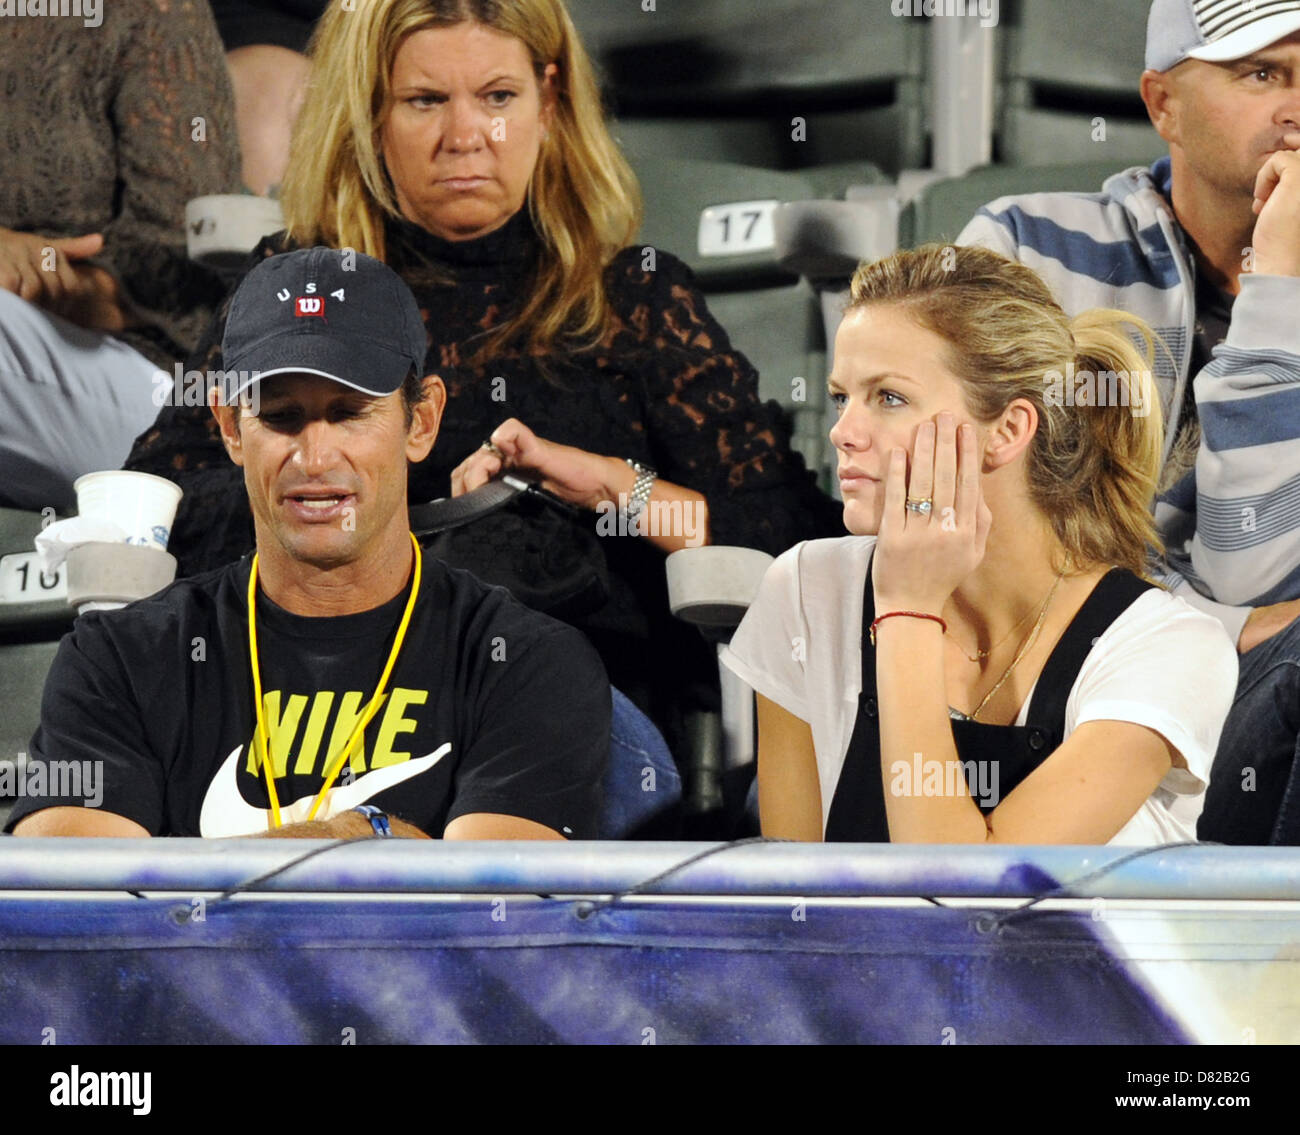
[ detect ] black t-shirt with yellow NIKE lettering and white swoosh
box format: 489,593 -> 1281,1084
7,555 -> 611,839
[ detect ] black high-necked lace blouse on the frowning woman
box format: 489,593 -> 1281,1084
126,211 -> 844,733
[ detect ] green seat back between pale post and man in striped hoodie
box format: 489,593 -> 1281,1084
995,0 -> 1162,168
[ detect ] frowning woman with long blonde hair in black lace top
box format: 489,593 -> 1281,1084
127,0 -> 844,741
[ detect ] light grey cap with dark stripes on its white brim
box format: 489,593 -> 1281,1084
1147,0 -> 1300,72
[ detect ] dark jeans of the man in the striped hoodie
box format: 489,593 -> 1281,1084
1196,620 -> 1300,846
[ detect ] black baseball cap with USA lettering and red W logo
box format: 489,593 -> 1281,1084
221,247 -> 428,404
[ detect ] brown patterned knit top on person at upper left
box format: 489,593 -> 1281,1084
0,0 -> 239,366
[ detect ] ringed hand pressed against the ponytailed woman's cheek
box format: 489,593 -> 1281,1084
871,413 -> 992,615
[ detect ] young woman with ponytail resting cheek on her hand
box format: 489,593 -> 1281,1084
724,246 -> 1236,844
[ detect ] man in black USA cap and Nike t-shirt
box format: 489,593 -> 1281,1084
8,248 -> 610,839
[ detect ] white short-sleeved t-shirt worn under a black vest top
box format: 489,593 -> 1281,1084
722,536 -> 1236,846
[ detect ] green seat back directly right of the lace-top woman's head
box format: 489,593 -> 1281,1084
568,0 -> 926,172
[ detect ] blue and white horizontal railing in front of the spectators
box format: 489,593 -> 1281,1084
0,839 -> 1300,901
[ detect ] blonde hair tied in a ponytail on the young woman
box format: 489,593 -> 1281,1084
848,244 -> 1164,575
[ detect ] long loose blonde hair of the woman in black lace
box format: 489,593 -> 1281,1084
281,0 -> 641,354
